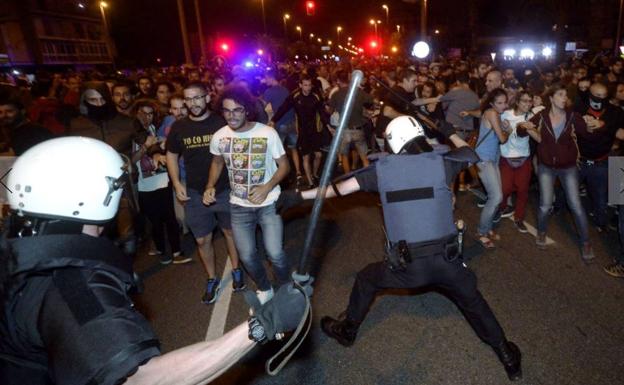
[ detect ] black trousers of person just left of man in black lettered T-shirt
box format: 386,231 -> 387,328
139,185 -> 180,253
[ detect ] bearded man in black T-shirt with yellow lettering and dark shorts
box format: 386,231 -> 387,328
167,82 -> 245,304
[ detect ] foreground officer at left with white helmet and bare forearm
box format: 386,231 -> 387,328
0,137 -> 311,385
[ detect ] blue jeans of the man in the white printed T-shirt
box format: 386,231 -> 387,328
230,203 -> 290,291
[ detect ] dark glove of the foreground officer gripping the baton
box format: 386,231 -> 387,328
245,281 -> 313,343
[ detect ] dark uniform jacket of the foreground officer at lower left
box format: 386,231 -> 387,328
0,235 -> 160,385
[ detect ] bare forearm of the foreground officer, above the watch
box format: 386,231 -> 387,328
124,322 -> 257,385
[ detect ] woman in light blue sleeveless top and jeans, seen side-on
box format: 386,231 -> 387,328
475,88 -> 508,249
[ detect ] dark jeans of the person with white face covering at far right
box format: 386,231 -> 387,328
580,161 -> 609,227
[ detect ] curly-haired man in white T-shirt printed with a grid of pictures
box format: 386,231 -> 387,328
203,86 -> 290,304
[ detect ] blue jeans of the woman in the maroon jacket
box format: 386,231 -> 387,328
537,164 -> 589,244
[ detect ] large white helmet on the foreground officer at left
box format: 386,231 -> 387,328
8,137 -> 125,224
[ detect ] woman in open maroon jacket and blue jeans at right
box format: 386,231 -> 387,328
525,85 -> 595,263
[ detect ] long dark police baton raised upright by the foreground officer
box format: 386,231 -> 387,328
296,70 -> 364,277
